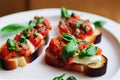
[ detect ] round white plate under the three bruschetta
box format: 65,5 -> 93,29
0,9 -> 120,80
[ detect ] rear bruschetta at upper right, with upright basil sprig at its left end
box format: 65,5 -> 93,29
58,8 -> 103,44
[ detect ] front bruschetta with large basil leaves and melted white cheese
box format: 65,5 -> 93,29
45,34 -> 108,77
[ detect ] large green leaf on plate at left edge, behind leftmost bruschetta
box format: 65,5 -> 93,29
0,24 -> 25,37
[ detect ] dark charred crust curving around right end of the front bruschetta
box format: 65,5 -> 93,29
85,56 -> 108,77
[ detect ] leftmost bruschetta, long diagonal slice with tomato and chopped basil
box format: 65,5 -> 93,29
0,16 -> 51,70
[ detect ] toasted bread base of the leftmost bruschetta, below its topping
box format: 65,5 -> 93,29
0,40 -> 45,70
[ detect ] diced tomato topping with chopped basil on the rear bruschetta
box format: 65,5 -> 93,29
58,14 -> 93,40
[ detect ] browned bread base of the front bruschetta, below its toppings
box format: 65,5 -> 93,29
45,48 -> 107,76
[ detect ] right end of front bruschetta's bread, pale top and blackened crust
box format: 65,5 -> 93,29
85,55 -> 107,77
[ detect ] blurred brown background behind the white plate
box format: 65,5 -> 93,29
0,0 -> 120,23
